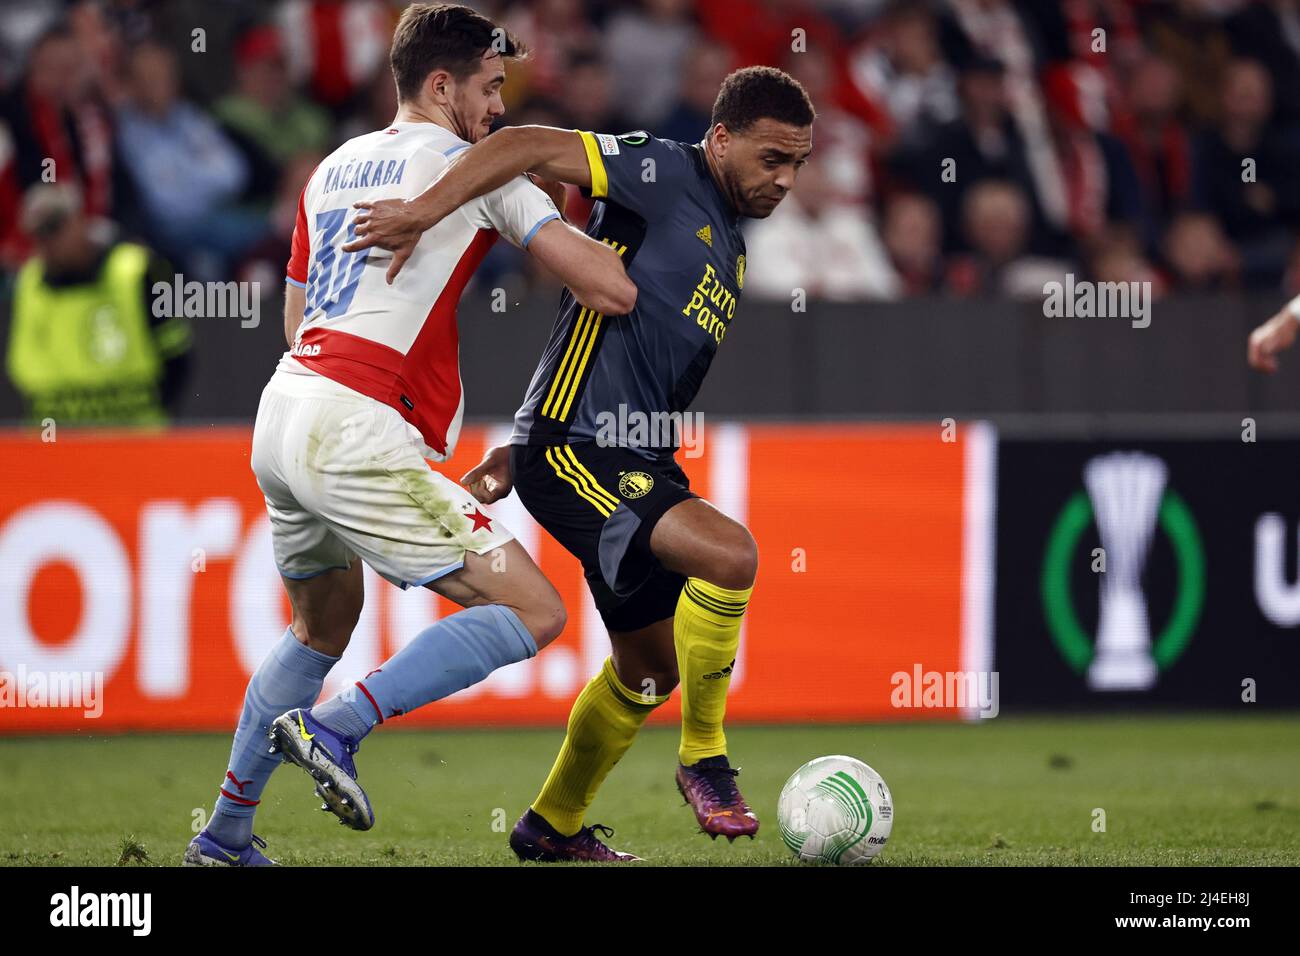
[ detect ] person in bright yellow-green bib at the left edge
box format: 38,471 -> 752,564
5,183 -> 191,425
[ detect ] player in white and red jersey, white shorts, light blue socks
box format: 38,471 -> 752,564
185,4 -> 636,866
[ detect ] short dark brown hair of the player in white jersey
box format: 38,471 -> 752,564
389,4 -> 528,101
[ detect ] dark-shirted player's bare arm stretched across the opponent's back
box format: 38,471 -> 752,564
343,126 -> 592,282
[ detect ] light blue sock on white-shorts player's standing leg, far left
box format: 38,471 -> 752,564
207,630 -> 338,849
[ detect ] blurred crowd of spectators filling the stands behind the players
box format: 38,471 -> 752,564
0,0 -> 1300,300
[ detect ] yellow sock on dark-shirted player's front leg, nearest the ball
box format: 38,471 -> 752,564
672,578 -> 754,766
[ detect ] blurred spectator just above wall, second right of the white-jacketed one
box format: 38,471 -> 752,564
946,179 -> 1067,298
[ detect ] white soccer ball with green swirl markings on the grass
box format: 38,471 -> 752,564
776,757 -> 893,865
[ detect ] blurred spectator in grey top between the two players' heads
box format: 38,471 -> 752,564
602,0 -> 716,128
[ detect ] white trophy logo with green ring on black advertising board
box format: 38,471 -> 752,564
1041,451 -> 1205,691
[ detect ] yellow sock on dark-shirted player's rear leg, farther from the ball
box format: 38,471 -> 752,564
533,657 -> 668,836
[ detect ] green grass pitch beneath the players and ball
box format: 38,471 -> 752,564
0,714 -> 1300,866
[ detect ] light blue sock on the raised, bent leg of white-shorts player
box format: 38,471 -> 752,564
312,605 -> 537,740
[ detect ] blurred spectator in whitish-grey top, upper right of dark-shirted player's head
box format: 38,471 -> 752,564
847,4 -> 959,148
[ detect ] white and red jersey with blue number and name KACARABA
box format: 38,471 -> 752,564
280,122 -> 559,460
